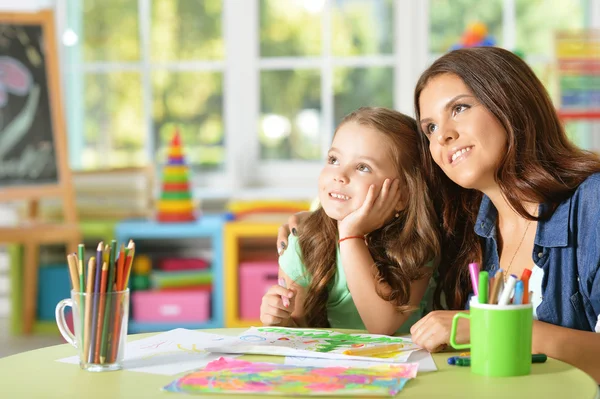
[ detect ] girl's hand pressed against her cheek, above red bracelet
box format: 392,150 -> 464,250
338,179 -> 400,238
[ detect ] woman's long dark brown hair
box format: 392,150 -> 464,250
414,47 -> 600,309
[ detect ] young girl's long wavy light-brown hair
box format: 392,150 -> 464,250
299,107 -> 440,327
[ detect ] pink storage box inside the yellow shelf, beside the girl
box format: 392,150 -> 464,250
239,262 -> 279,320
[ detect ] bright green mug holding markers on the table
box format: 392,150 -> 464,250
450,301 -> 533,377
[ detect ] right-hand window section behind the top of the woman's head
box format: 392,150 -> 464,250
429,0 -> 598,148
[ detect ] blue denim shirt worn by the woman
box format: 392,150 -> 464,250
475,173 -> 600,331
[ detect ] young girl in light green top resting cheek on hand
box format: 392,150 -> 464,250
260,108 -> 439,335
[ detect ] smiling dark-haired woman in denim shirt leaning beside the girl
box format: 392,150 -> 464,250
411,47 -> 600,382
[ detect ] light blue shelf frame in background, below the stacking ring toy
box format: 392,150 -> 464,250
116,214 -> 227,333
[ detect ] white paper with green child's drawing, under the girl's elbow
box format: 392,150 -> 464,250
206,327 -> 420,363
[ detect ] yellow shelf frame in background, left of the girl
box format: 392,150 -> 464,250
224,220 -> 285,328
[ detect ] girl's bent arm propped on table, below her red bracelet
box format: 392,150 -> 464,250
340,239 -> 429,335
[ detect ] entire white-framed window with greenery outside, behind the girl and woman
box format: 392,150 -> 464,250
57,0 -> 586,197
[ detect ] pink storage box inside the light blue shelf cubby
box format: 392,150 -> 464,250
131,291 -> 210,322
